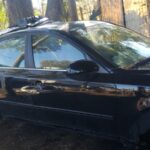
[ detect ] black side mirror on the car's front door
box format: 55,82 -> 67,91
68,60 -> 99,74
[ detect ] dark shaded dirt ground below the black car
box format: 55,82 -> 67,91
0,119 -> 125,150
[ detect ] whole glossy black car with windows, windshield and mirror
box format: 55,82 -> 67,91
0,17 -> 150,145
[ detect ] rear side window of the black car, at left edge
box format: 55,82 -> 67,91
0,37 -> 25,68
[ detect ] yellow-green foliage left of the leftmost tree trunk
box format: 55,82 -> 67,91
0,0 -> 8,30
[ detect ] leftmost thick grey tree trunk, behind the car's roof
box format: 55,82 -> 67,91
6,0 -> 33,26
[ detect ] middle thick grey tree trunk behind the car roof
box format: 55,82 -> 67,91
46,0 -> 63,21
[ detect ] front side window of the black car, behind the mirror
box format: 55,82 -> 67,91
32,34 -> 86,70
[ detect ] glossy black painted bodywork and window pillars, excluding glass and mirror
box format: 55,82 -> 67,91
0,21 -> 150,145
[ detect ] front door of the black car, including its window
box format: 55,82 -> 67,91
24,32 -> 116,134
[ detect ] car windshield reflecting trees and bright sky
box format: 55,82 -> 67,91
69,22 -> 150,69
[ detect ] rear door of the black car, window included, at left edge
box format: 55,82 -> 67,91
0,32 -> 37,117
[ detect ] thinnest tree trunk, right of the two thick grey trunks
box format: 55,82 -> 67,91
68,0 -> 78,21
